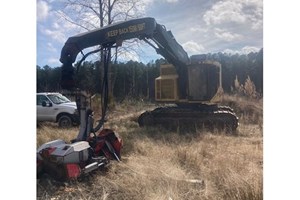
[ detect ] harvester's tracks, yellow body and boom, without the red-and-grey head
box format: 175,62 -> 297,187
60,17 -> 238,130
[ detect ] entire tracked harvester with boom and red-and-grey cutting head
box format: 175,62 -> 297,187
37,17 -> 238,179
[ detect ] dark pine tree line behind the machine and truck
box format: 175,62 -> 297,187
36,49 -> 263,100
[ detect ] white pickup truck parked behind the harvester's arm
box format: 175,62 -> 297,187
36,92 -> 79,127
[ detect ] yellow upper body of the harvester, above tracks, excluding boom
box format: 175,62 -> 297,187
155,61 -> 223,103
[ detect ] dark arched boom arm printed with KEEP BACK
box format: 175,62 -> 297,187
60,17 -> 190,66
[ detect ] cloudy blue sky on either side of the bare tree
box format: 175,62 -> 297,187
37,0 -> 263,67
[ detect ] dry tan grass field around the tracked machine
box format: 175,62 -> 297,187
36,96 -> 263,200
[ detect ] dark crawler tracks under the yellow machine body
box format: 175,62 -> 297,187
138,104 -> 238,132
